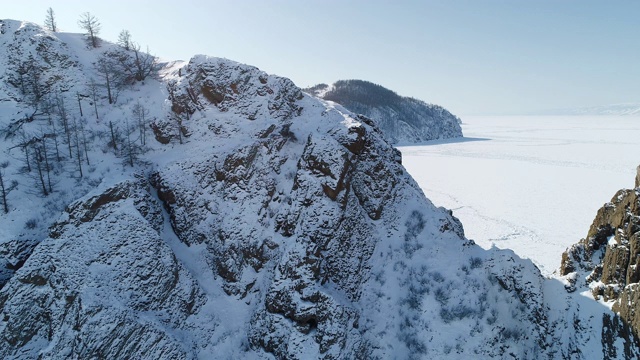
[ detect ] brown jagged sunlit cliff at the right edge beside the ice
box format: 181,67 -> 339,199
560,167 -> 640,358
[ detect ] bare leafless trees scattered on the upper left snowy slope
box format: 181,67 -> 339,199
0,8 -> 158,213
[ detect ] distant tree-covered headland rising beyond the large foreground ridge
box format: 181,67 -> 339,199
305,80 -> 462,145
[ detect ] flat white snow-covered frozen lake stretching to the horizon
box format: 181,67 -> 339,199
399,116 -> 640,275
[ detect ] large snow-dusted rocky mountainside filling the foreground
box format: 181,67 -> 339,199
0,20 -> 638,359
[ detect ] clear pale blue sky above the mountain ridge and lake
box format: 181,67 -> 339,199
5,0 -> 640,115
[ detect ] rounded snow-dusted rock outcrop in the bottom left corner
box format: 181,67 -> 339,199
0,180 -> 205,359
